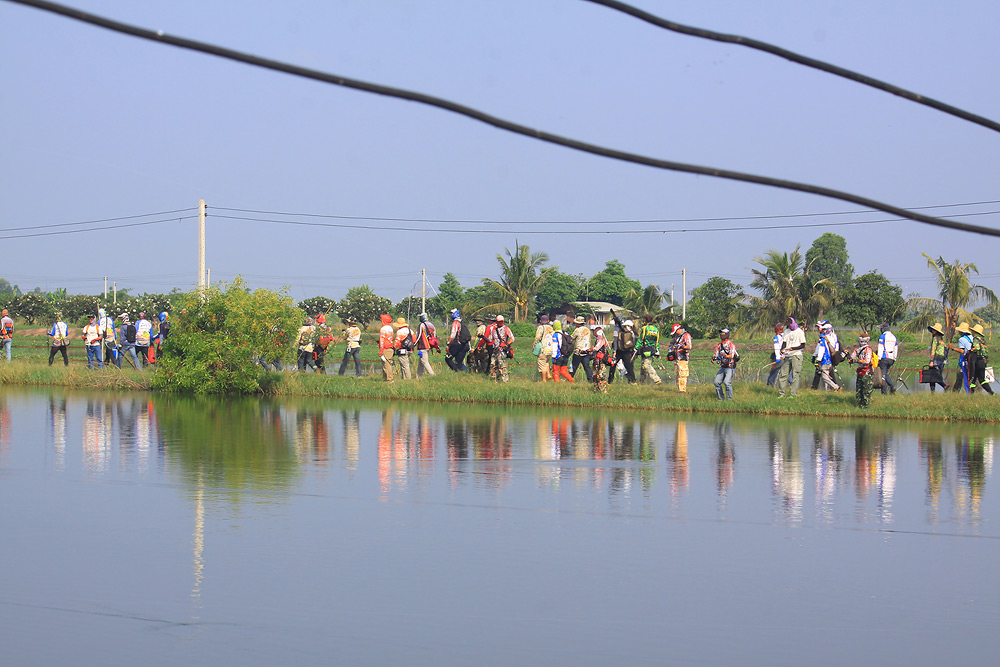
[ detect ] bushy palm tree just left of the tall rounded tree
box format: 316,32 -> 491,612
740,246 -> 834,335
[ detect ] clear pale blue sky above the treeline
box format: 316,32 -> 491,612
0,0 -> 1000,302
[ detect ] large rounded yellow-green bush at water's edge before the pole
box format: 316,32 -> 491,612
152,277 -> 302,394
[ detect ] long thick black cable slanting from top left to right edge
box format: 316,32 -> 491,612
6,0 -> 1000,237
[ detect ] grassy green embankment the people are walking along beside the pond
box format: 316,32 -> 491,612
0,328 -> 1000,423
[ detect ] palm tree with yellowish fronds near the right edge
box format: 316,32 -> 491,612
903,252 -> 997,340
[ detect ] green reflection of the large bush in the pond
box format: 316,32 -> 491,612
153,394 -> 298,490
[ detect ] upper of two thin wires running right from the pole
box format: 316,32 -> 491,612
212,200 -> 1000,225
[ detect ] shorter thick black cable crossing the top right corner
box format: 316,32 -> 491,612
585,0 -> 1000,132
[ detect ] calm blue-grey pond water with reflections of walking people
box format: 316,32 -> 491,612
0,388 -> 1000,665
